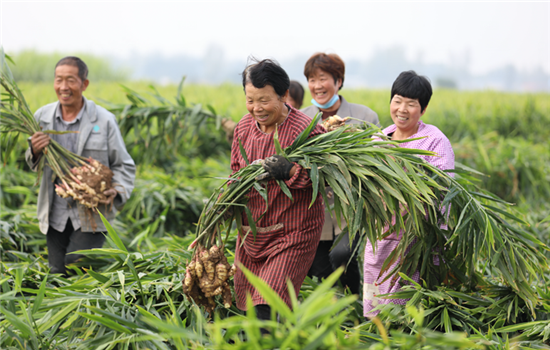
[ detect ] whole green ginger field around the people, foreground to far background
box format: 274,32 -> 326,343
0,82 -> 550,350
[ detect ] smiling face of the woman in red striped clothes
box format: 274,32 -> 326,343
244,83 -> 288,134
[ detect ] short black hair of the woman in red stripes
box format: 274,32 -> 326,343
242,57 -> 290,98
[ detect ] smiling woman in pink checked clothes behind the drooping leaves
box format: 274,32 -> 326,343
363,71 -> 455,317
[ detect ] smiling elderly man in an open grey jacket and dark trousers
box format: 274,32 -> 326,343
25,56 -> 135,274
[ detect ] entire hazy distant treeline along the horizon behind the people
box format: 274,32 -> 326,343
8,45 -> 550,92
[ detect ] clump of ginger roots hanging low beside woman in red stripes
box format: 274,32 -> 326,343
183,245 -> 235,314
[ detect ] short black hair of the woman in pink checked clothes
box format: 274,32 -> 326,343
390,70 -> 432,112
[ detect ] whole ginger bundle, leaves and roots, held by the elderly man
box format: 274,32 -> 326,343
0,48 -> 113,209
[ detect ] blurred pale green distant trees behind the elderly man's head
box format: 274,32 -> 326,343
8,50 -> 131,82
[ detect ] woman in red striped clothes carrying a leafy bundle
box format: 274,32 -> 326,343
231,59 -> 324,319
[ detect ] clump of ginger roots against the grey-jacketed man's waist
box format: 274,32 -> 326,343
55,158 -> 113,209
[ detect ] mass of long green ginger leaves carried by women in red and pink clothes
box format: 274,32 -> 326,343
190,115 -> 548,312
